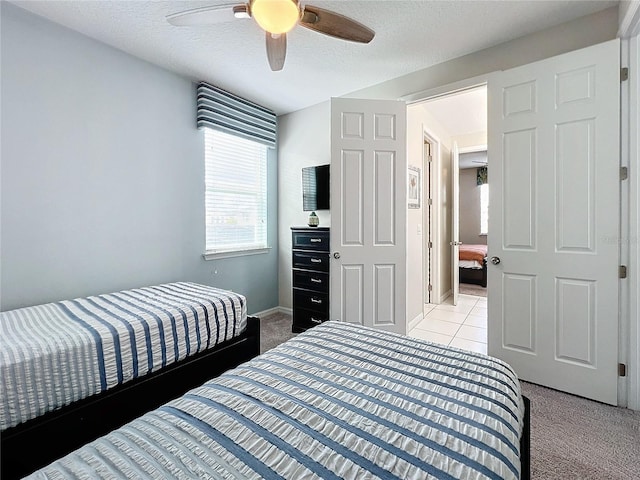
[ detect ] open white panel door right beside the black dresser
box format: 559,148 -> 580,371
330,98 -> 407,333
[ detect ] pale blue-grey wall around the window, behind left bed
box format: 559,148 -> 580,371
0,2 -> 278,312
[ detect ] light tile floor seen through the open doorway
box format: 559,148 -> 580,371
409,294 -> 487,353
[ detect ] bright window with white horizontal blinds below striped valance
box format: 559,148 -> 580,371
204,128 -> 269,258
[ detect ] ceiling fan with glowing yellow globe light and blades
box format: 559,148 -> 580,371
167,0 -> 375,71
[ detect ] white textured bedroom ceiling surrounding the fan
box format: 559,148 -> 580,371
12,0 -> 618,114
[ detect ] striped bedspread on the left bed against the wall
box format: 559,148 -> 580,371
0,282 -> 247,430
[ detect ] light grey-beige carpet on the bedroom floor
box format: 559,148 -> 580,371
260,314 -> 640,480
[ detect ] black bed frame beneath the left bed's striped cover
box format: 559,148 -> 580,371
0,317 -> 260,480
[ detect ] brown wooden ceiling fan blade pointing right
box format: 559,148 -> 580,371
298,5 -> 376,43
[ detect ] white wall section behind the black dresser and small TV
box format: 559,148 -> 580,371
278,101 -> 331,308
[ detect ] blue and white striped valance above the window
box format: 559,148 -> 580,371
198,83 -> 277,147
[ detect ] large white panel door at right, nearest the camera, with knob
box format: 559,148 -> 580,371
488,40 -> 620,404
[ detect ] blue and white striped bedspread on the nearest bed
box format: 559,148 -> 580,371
29,322 -> 524,480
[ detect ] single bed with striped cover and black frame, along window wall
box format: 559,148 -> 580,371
0,282 -> 260,478
